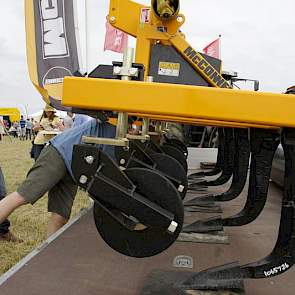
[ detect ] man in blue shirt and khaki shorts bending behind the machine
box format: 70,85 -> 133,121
0,119 -> 116,236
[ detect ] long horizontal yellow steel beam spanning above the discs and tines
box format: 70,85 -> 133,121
63,77 -> 295,127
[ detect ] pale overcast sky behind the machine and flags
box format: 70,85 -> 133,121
0,0 -> 295,114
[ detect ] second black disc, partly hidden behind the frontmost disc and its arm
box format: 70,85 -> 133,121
149,153 -> 188,199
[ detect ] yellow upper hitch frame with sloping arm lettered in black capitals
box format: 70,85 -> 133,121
108,0 -> 231,88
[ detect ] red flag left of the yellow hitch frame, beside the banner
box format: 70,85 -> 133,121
104,20 -> 128,53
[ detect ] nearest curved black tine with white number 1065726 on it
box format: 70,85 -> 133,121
179,128 -> 295,290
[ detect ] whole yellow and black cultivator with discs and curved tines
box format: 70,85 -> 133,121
25,0 -> 295,290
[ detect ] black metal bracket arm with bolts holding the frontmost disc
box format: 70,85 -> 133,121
72,145 -> 177,228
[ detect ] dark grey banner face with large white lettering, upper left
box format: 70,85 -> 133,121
27,0 -> 80,101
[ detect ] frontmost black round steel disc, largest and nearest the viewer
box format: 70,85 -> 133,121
94,168 -> 183,257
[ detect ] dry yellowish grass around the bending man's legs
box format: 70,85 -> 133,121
0,137 -> 90,275
